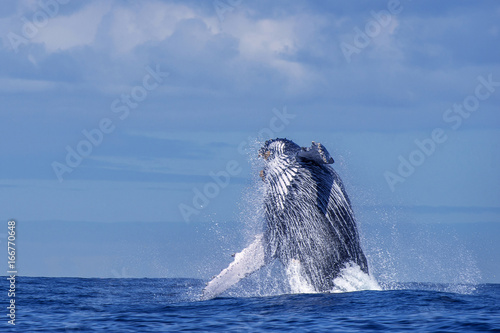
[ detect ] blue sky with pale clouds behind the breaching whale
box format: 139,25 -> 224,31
0,0 -> 500,283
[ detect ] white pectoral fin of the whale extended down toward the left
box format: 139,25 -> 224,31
201,234 -> 265,300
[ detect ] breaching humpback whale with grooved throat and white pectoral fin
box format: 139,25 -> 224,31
202,138 -> 368,299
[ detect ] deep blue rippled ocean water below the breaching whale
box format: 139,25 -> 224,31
0,277 -> 500,333
